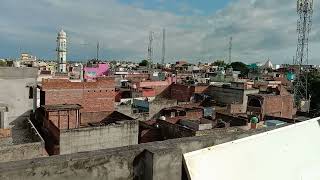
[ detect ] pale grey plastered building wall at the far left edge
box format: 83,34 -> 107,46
0,67 -> 38,128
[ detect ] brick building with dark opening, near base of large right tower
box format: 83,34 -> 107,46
247,86 -> 296,120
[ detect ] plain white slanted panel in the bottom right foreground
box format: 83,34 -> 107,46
184,118 -> 320,180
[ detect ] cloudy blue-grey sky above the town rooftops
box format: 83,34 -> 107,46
0,0 -> 320,64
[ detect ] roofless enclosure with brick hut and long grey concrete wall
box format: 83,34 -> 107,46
37,104 -> 139,155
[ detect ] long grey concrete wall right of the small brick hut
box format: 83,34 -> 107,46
60,121 -> 139,154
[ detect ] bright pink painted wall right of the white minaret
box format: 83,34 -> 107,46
84,64 -> 109,80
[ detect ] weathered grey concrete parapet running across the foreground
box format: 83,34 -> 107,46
0,124 -> 288,180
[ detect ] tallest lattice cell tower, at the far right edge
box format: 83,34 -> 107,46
294,0 -> 313,112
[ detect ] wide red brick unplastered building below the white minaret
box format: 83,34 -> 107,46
40,77 -> 115,124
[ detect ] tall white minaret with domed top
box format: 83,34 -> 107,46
56,30 -> 67,73
